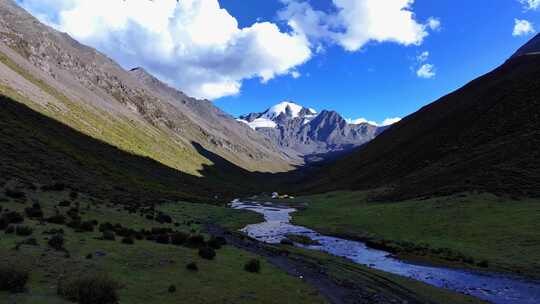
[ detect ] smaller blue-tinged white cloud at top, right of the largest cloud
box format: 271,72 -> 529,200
279,0 -> 440,51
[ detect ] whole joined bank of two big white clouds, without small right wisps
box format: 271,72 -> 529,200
17,0 -> 441,99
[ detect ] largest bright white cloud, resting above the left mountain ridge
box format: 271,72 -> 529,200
22,0 -> 312,98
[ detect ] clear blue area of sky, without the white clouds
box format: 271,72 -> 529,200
216,0 -> 540,121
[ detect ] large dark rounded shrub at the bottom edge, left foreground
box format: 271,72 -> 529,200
57,275 -> 120,304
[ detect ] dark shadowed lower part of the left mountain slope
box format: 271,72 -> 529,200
0,96 -> 274,204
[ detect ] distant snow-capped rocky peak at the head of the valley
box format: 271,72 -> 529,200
238,101 -> 385,161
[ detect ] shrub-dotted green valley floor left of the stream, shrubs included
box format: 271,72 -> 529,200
0,179 -> 325,304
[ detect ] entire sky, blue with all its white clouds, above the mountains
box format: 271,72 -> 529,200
18,0 -> 540,122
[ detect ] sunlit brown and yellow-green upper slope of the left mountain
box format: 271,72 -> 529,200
0,0 -> 294,179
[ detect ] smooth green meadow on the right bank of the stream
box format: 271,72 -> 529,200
283,191 -> 540,278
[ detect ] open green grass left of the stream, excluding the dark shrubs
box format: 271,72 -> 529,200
0,181 -> 325,304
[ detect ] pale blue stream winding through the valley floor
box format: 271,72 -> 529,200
231,200 -> 540,304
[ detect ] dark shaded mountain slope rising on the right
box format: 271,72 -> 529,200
304,36 -> 540,198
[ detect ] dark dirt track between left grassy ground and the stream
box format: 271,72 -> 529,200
206,224 -> 425,304
